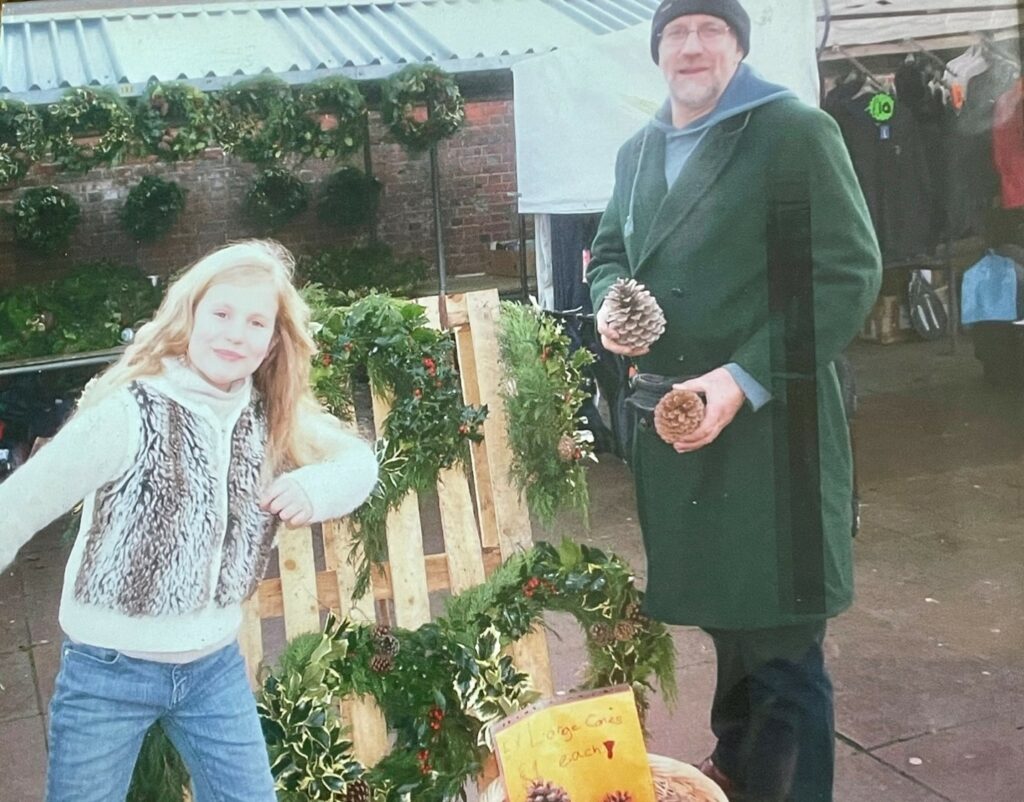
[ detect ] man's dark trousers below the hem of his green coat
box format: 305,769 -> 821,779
707,621 -> 836,802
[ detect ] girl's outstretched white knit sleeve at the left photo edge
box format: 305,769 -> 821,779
0,392 -> 139,569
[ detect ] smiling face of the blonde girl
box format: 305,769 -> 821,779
188,281 -> 278,390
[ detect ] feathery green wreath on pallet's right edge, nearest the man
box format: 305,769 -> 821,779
498,301 -> 596,524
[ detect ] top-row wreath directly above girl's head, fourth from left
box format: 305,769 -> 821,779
213,76 -> 295,164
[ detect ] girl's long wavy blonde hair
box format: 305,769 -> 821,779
79,240 -> 329,473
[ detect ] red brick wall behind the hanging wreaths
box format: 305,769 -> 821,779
0,99 -> 518,287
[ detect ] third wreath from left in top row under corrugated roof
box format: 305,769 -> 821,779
136,83 -> 213,162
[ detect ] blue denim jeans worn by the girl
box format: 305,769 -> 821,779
46,641 -> 276,802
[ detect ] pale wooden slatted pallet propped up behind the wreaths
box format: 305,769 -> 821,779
240,290 -> 552,765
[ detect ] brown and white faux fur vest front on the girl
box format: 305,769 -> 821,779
75,382 -> 278,616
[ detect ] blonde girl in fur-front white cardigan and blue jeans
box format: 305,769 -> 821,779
0,241 -> 377,802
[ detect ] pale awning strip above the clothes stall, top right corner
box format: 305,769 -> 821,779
816,0 -> 1022,46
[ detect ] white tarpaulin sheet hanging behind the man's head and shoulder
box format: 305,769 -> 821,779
512,0 -> 818,214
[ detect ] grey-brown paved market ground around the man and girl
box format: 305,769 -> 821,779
0,335 -> 1024,802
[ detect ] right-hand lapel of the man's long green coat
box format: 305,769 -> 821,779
633,112 -> 751,273
